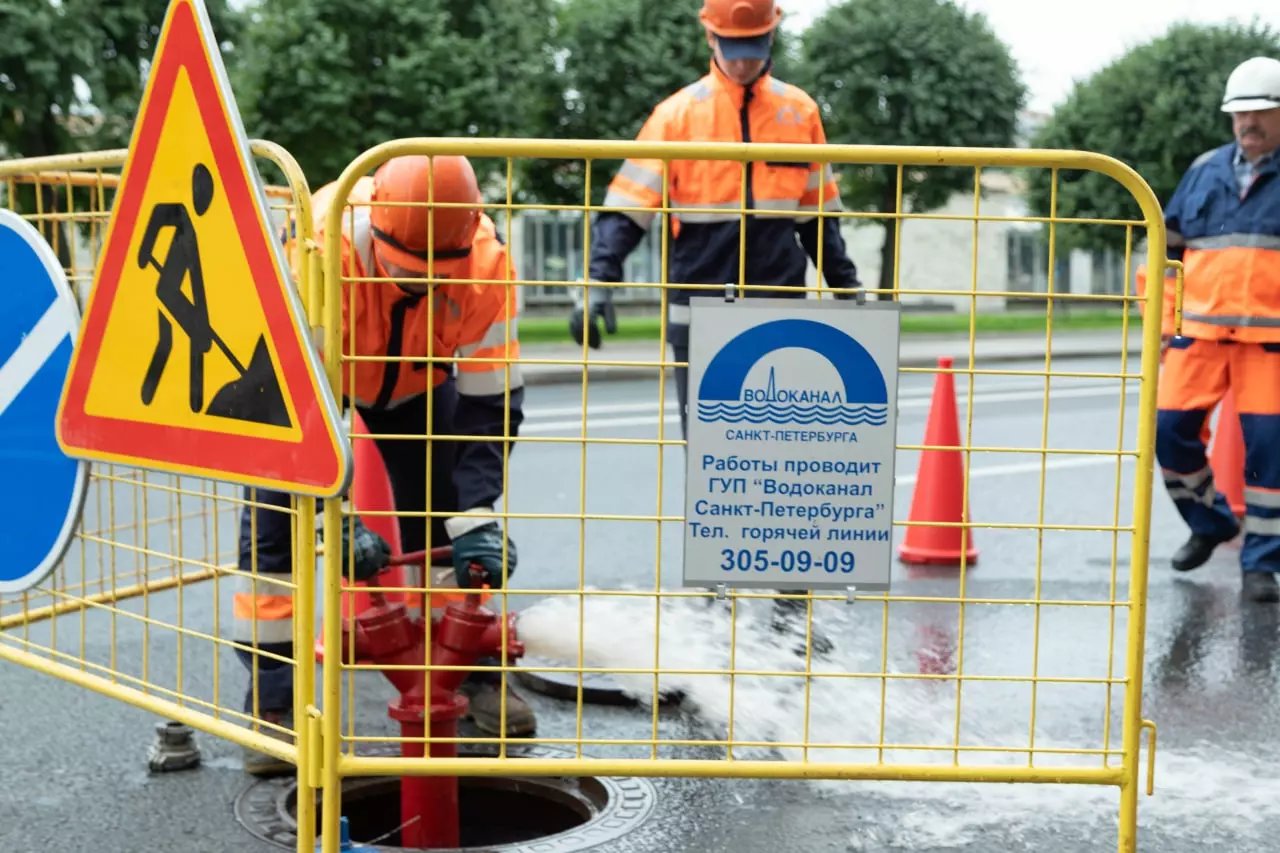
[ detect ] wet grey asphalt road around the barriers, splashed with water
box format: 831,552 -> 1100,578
0,348 -> 1280,853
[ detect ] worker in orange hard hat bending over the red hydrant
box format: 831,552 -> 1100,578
234,156 -> 536,775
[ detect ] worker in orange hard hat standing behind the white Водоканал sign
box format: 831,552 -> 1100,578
570,0 -> 861,651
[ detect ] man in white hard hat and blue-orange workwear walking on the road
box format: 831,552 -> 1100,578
1138,56 -> 1280,602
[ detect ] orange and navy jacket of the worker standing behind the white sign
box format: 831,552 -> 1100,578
589,59 -> 859,342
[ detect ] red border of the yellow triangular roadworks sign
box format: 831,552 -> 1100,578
59,0 -> 349,494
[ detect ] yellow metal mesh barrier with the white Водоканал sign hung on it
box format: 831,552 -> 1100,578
311,138 -> 1165,853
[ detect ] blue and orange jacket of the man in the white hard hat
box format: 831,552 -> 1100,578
1137,142 -> 1280,343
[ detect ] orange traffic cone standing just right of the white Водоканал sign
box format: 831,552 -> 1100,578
897,356 -> 978,566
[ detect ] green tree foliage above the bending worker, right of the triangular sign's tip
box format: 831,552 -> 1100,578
233,0 -> 554,188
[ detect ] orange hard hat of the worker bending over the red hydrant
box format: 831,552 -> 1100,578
370,155 -> 483,273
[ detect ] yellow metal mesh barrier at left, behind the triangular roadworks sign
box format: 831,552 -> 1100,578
0,141 -> 319,814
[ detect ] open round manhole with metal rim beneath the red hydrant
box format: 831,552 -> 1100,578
234,744 -> 655,853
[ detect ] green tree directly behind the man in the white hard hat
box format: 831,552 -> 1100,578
1028,24 -> 1280,251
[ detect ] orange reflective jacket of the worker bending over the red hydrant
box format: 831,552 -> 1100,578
314,178 -> 524,511
